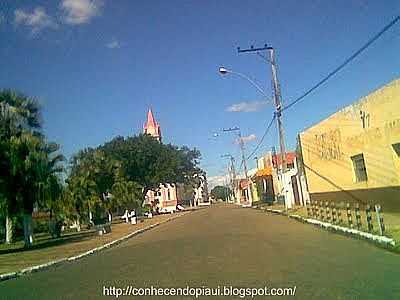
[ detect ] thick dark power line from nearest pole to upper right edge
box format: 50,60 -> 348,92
281,16 -> 400,111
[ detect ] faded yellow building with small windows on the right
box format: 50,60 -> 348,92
300,79 -> 400,211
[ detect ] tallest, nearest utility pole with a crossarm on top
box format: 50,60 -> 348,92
237,45 -> 287,173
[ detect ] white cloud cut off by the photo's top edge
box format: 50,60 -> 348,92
60,0 -> 104,25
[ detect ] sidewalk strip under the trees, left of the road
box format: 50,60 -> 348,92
0,211 -> 190,275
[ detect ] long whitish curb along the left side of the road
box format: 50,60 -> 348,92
0,211 -> 191,282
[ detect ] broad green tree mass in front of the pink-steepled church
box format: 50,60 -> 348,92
67,135 -> 201,221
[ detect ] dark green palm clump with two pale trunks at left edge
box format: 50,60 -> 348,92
0,90 -> 64,246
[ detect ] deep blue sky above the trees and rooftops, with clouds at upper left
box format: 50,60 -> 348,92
0,0 -> 400,185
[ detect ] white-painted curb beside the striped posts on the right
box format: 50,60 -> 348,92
263,208 -> 396,249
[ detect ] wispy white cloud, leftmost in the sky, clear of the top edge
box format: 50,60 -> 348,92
14,6 -> 57,34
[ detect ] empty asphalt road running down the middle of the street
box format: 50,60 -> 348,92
0,205 -> 400,299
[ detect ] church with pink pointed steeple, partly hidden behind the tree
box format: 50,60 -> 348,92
143,109 -> 178,211
